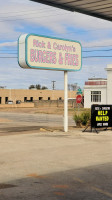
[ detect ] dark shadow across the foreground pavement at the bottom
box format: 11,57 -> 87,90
0,163 -> 112,200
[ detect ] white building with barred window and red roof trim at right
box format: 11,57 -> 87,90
84,65 -> 112,108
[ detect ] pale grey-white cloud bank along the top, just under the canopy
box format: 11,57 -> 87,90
0,0 -> 112,39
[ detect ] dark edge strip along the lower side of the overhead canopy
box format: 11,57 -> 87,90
30,0 -> 112,21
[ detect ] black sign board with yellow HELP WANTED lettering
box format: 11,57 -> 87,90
91,105 -> 112,128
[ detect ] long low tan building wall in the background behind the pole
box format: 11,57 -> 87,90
0,89 -> 76,104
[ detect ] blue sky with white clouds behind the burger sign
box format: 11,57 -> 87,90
0,0 -> 112,89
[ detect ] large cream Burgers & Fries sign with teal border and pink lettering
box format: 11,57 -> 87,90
18,34 -> 82,71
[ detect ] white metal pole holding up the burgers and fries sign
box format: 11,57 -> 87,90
64,71 -> 68,132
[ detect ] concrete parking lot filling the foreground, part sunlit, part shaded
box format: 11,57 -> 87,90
0,113 -> 112,200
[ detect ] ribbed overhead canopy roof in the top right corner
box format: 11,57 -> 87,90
31,0 -> 112,21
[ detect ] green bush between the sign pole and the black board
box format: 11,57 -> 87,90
73,111 -> 91,126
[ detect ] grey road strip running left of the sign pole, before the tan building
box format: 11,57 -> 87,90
0,112 -> 75,132
